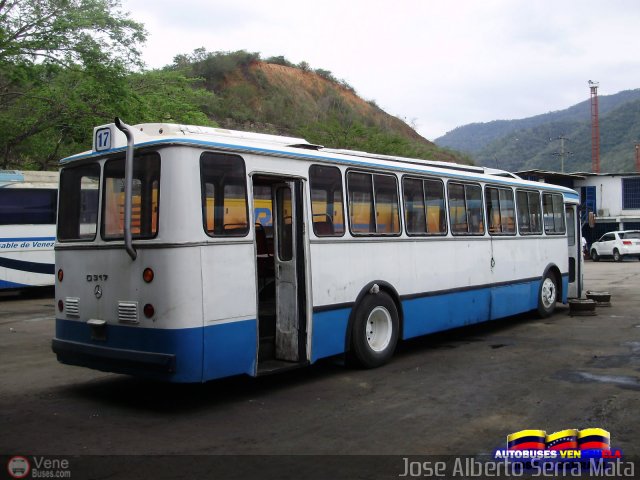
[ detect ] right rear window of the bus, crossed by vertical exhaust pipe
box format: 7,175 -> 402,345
102,153 -> 160,240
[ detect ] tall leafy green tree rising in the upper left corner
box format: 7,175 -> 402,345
0,0 -> 146,168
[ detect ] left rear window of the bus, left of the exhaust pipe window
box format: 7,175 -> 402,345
58,163 -> 100,241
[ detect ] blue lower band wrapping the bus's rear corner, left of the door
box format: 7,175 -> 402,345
56,318 -> 257,382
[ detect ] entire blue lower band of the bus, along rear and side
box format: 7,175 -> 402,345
56,275 -> 569,382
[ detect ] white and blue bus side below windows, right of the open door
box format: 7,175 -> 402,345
311,236 -> 567,361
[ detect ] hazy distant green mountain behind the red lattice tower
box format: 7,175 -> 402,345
436,89 -> 640,172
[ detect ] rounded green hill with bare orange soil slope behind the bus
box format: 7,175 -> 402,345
166,49 -> 470,163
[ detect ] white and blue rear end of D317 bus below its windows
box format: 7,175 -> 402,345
54,247 -> 204,382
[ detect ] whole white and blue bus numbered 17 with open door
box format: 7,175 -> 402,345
52,119 -> 582,382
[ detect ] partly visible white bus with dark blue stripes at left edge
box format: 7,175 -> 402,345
0,170 -> 58,290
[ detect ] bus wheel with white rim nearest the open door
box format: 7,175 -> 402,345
350,292 -> 399,368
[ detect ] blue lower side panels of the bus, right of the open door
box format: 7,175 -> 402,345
311,275 -> 569,362
